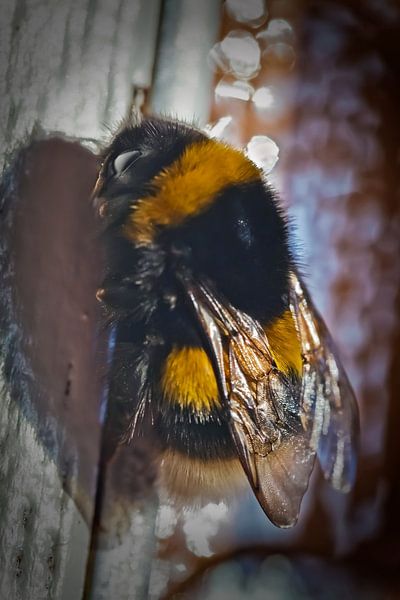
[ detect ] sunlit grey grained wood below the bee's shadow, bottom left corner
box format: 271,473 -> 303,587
0,397 -> 90,600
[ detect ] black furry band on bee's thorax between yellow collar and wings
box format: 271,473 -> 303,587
160,181 -> 291,324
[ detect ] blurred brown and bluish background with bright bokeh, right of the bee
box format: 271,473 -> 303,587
146,0 -> 400,599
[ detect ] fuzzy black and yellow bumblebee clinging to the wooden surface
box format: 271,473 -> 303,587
93,118 -> 358,527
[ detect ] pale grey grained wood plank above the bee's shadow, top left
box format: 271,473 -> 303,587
0,0 -> 161,166
